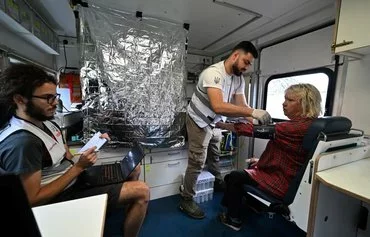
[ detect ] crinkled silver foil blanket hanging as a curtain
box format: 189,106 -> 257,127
80,4 -> 187,147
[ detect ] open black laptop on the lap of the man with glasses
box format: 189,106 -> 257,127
79,142 -> 145,186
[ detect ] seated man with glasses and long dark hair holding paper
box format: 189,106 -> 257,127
0,64 -> 149,236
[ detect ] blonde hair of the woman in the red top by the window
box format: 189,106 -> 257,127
285,83 -> 322,118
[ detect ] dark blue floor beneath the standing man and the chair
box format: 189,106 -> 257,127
104,193 -> 306,237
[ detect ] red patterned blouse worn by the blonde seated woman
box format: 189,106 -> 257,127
234,118 -> 313,198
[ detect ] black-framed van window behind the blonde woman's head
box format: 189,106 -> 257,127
264,68 -> 334,121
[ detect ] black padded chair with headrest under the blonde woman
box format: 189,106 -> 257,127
244,116 -> 363,220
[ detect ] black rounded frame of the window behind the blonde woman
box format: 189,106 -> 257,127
262,67 -> 336,122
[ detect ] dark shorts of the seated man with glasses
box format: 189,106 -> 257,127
49,181 -> 123,211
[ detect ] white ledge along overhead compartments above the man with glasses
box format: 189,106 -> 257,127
0,10 -> 59,55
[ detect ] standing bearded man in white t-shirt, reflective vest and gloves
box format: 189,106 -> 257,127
179,41 -> 271,219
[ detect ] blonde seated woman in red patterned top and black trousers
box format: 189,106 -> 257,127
216,84 -> 321,230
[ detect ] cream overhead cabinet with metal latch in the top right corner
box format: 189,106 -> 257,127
332,0 -> 370,57
